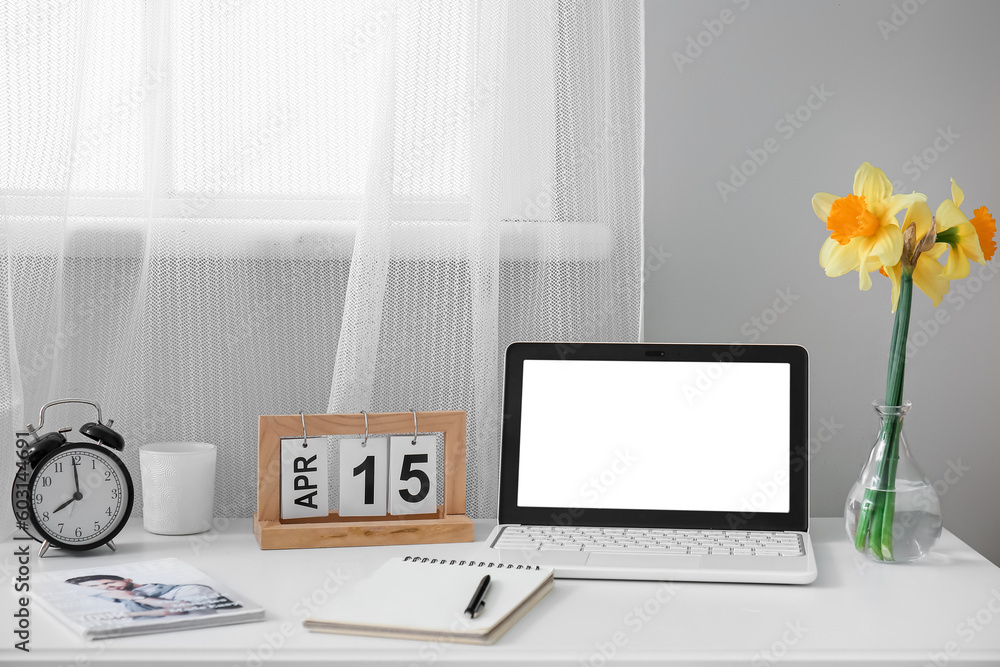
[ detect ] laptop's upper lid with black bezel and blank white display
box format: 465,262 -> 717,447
501,343 -> 808,530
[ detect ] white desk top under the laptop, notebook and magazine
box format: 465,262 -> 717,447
0,519 -> 1000,667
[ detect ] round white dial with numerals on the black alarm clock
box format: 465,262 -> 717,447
28,443 -> 133,550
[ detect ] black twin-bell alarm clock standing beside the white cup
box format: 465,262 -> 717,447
12,398 -> 134,556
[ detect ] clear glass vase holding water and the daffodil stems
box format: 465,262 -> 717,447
844,401 -> 941,563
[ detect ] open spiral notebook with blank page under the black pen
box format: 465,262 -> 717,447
302,556 -> 553,644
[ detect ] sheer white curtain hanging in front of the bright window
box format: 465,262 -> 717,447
0,0 -> 643,526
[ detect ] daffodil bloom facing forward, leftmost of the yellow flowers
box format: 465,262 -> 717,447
812,162 -> 927,290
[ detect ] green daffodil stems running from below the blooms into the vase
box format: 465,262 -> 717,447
854,268 -> 913,560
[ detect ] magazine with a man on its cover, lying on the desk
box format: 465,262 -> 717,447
32,558 -> 264,639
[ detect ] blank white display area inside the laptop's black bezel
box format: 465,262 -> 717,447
517,360 -> 790,512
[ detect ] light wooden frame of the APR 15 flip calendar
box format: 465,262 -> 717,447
253,410 -> 473,549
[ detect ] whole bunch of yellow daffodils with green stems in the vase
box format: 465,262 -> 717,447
812,162 -> 997,561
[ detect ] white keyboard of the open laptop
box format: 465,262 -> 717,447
493,526 -> 805,557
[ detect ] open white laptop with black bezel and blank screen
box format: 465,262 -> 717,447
487,343 -> 816,584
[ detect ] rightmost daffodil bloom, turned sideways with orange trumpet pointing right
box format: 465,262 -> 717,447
934,178 -> 996,280
